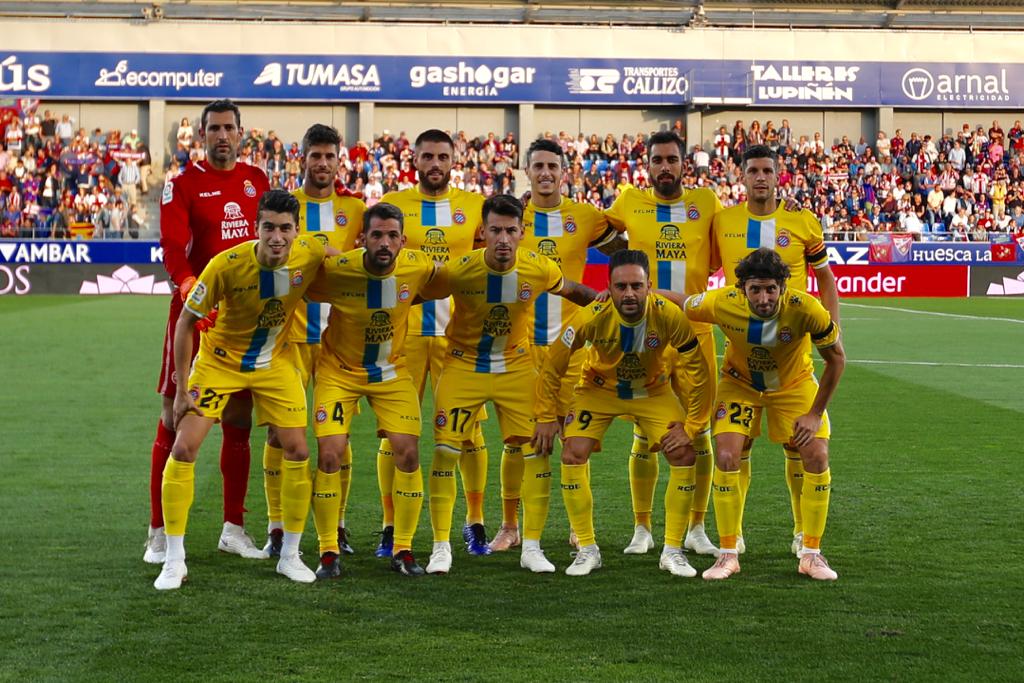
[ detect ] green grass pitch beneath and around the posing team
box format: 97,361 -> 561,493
0,296 -> 1024,681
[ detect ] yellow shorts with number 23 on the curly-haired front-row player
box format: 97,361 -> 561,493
712,377 -> 831,443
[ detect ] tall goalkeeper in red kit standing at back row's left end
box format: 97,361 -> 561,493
143,99 -> 269,564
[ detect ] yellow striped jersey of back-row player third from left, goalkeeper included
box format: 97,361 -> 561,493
381,185 -> 483,337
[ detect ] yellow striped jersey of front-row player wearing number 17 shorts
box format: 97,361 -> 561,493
428,247 -> 563,374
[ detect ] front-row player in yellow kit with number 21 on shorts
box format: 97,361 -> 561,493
154,189 -> 325,590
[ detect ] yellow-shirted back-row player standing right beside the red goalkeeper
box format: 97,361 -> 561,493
263,123 -> 367,557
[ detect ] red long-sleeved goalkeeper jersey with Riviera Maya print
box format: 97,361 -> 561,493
160,161 -> 270,285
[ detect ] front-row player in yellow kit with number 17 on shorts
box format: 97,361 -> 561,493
419,195 -> 596,573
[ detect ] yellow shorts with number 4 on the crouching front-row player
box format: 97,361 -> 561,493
313,365 -> 420,438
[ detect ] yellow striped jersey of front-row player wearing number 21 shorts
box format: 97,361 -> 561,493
185,237 -> 325,372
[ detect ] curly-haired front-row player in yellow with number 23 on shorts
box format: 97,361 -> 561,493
677,247 -> 846,581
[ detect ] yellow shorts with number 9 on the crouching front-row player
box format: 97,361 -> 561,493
564,386 -> 695,453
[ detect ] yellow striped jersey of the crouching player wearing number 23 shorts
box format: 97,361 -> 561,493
684,287 -> 839,391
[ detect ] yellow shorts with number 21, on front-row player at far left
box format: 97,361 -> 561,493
188,347 -> 306,429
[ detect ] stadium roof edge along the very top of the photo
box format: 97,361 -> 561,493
6,0 -> 1024,30
